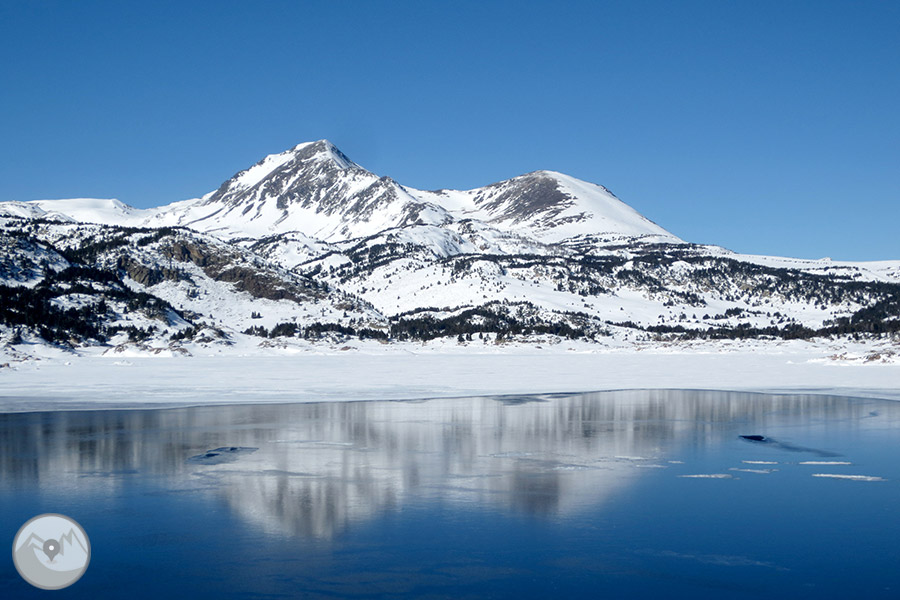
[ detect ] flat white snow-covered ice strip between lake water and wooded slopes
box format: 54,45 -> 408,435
0,340 -> 900,411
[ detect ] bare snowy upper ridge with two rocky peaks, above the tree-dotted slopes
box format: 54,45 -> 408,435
0,140 -> 680,243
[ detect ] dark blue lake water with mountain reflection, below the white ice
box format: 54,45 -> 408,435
0,391 -> 900,598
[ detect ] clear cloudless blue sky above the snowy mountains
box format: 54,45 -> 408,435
0,0 -> 900,260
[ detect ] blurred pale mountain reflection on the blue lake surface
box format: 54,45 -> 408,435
0,391 -> 900,538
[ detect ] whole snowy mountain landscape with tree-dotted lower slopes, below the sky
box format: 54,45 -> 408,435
0,140 -> 900,351
